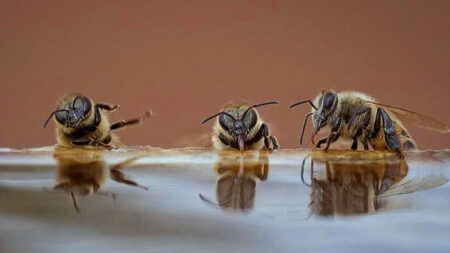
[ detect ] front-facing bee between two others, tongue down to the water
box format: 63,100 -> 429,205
202,101 -> 279,151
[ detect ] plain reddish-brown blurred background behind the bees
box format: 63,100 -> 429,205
0,0 -> 450,148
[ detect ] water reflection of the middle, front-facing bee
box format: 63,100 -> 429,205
199,151 -> 269,212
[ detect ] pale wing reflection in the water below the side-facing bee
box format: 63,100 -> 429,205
381,176 -> 449,197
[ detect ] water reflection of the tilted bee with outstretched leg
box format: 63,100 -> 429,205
44,148 -> 148,213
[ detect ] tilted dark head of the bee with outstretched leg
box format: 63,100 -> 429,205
44,95 -> 92,129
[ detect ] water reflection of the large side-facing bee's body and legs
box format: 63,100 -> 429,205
301,153 -> 408,216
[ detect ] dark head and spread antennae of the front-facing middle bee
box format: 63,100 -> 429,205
202,101 -> 278,150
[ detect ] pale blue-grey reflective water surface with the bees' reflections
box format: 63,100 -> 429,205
0,148 -> 450,252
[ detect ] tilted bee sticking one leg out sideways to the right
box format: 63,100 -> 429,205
44,93 -> 152,149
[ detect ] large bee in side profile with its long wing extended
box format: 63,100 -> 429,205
290,90 -> 450,155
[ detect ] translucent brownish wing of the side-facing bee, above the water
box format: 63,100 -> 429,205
366,101 -> 450,133
